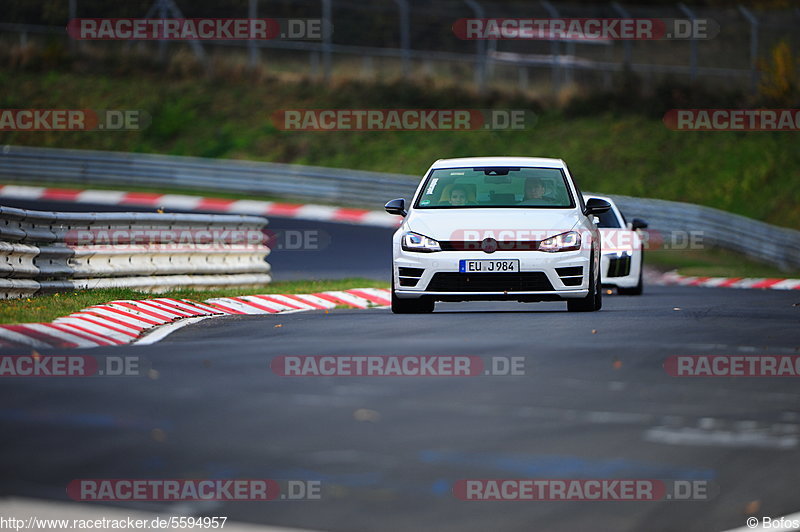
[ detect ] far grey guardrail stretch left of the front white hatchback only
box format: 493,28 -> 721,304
0,146 -> 419,205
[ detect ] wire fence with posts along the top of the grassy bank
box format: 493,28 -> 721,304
0,0 -> 800,91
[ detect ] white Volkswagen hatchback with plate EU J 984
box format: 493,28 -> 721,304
386,157 -> 611,313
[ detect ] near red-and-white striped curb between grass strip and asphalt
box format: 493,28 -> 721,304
0,288 -> 391,348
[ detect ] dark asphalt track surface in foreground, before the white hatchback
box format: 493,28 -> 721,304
0,197 -> 800,531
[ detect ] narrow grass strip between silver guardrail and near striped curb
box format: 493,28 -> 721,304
0,278 -> 388,324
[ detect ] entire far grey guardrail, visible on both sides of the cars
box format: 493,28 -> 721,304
0,146 -> 800,269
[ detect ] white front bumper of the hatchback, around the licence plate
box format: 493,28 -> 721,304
393,249 -> 589,301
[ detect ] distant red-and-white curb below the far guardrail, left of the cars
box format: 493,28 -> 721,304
0,185 -> 401,227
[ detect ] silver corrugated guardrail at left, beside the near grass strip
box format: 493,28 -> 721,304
0,206 -> 271,299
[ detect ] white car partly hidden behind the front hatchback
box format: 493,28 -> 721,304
583,194 -> 647,296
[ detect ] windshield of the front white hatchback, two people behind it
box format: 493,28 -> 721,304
414,166 -> 575,209
